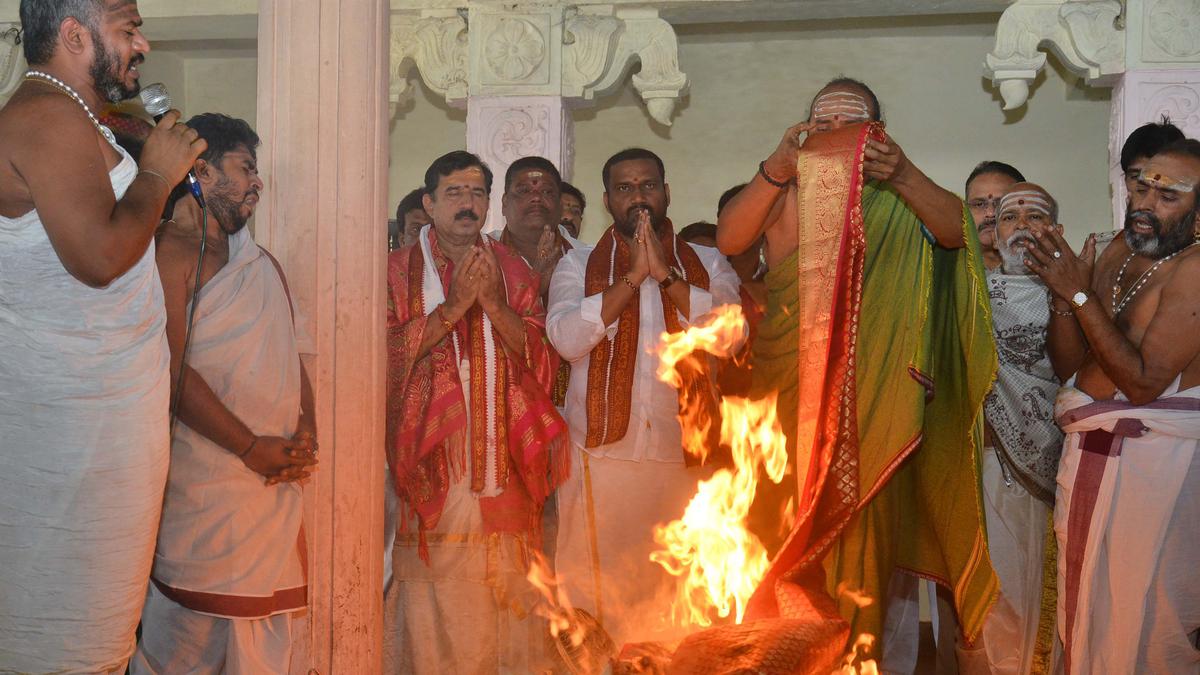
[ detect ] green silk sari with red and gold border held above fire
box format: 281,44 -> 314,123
746,123 -> 997,640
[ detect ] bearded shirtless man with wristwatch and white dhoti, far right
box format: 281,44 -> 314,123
1028,139 -> 1200,673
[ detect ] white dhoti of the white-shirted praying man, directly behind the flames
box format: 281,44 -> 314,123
554,446 -> 712,649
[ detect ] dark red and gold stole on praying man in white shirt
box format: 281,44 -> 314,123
583,220 -> 720,462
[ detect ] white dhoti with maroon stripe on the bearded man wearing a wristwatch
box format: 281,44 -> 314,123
1055,387 -> 1200,674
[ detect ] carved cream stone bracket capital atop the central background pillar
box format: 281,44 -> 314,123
391,4 -> 688,126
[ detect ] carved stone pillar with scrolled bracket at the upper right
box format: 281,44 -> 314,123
984,0 -> 1200,231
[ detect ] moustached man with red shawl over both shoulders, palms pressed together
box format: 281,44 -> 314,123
385,151 -> 568,674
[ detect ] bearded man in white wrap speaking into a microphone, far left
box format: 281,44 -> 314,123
0,0 -> 205,673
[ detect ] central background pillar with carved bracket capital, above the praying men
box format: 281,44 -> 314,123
391,0 -> 688,231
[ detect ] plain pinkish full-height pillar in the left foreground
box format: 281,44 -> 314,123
256,0 -> 389,674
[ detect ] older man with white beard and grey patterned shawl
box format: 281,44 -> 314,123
982,183 -> 1062,675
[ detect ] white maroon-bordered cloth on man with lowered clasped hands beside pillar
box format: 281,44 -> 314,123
154,229 -> 306,619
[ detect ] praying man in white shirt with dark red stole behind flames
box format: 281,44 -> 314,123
546,148 -> 738,645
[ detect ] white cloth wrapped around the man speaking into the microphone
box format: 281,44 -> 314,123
0,140 -> 170,673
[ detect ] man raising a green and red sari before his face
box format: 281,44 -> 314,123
718,78 -> 997,662
